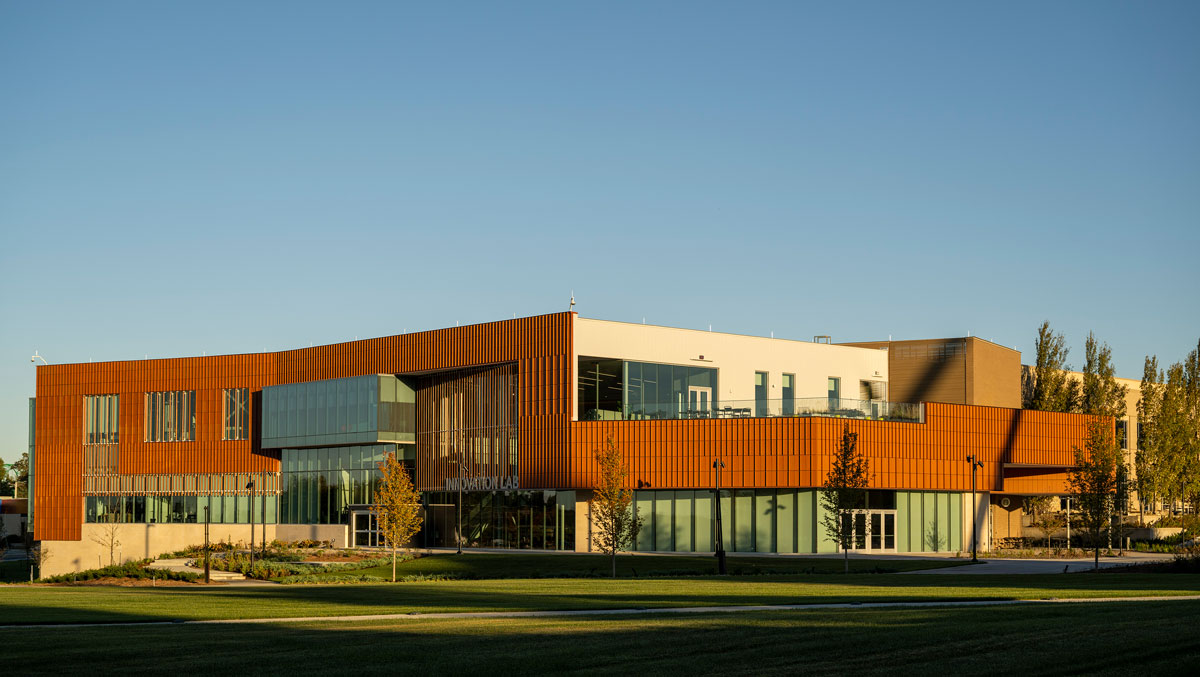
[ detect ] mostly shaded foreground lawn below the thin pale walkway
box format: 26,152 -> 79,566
4,597 -> 1200,676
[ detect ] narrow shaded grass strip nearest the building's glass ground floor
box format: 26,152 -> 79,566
300,552 -> 971,580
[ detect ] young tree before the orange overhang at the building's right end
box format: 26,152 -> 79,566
1068,418 -> 1124,569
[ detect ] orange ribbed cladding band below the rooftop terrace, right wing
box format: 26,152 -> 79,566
570,403 -> 1088,492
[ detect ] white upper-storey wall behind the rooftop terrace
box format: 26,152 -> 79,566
571,317 -> 888,419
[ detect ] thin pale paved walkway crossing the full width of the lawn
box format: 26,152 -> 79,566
16,594 -> 1200,630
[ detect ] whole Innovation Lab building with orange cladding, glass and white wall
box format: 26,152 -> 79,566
31,313 -> 1086,573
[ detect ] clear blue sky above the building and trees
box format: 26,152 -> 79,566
0,0 -> 1200,460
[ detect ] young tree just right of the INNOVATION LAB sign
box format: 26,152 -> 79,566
589,437 -> 642,579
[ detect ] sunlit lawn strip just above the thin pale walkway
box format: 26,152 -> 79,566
0,574 -> 1200,624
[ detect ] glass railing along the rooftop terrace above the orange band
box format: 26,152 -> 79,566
580,397 -> 925,423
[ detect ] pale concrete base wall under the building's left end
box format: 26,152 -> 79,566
42,523 -> 278,576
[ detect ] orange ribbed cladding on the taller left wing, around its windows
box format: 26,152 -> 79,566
34,313 -> 574,540
